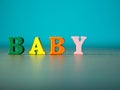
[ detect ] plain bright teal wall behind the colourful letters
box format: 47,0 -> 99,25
0,0 -> 120,48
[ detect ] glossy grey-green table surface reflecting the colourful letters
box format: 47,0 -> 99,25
0,49 -> 120,90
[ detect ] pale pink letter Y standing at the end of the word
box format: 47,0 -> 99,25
71,36 -> 87,55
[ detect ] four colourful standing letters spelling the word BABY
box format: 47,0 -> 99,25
9,36 -> 87,55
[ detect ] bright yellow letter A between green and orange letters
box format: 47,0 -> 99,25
29,37 -> 46,55
